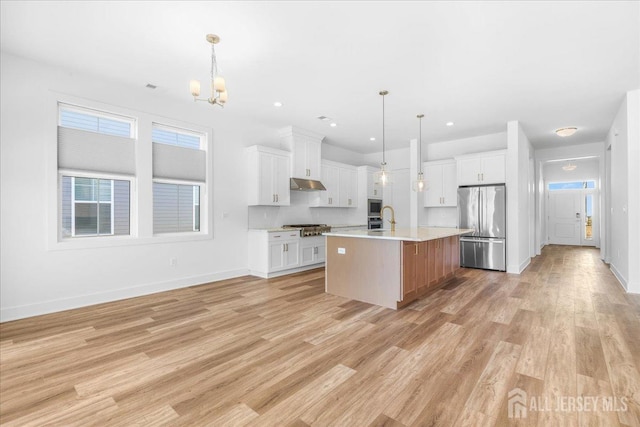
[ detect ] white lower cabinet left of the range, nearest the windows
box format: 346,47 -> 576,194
249,230 -> 301,277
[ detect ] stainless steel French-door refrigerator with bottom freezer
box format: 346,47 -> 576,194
458,184 -> 507,271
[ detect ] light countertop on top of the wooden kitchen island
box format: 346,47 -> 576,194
323,227 -> 473,242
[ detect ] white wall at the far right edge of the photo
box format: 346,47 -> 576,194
606,90 -> 640,293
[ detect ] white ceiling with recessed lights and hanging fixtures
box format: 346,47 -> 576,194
0,1 -> 640,153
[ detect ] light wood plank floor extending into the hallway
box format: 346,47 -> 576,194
0,246 -> 640,427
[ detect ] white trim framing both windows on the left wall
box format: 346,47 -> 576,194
48,94 -> 215,251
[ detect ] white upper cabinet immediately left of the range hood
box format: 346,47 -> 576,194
246,145 -> 291,206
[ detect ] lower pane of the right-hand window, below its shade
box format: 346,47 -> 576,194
153,182 -> 200,234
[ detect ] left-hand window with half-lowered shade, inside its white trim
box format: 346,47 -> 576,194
58,104 -> 135,238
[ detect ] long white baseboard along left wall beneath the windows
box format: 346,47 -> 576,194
0,269 -> 249,322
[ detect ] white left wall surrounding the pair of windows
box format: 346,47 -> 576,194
0,53 -> 268,321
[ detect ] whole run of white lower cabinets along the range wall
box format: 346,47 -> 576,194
248,229 -> 325,278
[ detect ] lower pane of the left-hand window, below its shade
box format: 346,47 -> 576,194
60,175 -> 130,237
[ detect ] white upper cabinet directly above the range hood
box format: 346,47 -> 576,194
280,126 -> 326,181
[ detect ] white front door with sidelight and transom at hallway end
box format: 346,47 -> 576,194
547,181 -> 599,246
